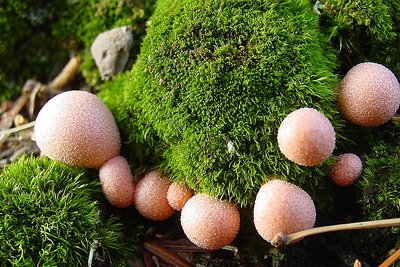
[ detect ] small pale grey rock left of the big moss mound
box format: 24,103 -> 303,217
90,26 -> 133,80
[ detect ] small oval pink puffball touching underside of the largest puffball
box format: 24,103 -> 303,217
99,156 -> 135,208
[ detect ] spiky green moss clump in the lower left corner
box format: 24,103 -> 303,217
0,157 -> 134,266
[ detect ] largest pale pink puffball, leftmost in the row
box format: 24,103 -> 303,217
34,91 -> 121,169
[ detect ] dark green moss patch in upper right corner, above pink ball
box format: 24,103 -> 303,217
321,0 -> 400,73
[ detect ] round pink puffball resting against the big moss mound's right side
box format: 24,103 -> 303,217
278,108 -> 335,166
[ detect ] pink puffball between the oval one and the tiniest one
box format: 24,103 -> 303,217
134,170 -> 175,221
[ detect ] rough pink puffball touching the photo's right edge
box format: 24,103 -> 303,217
337,62 -> 400,126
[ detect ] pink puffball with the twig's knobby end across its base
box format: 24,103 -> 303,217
254,179 -> 316,242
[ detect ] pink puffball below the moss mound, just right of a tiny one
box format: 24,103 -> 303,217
181,194 -> 240,249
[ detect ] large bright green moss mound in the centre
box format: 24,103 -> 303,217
108,0 -> 341,206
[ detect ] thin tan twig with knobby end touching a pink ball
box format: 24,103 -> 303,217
271,218 -> 400,247
